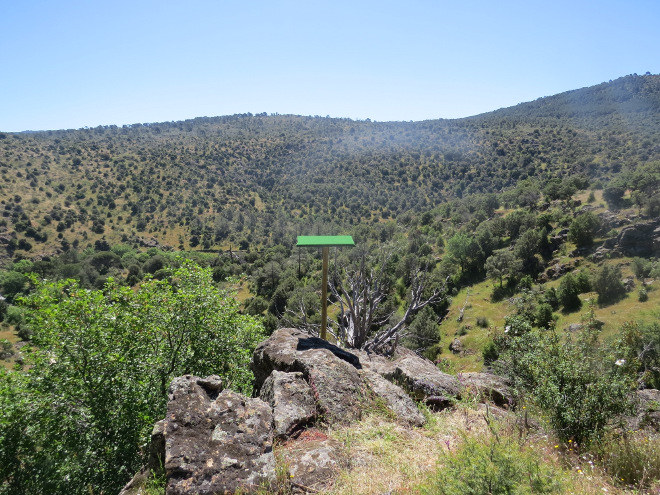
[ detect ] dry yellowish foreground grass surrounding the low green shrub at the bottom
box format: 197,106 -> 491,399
330,405 -> 639,495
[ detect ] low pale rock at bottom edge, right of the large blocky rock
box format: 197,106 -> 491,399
282,438 -> 344,493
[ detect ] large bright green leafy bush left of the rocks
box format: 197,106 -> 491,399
0,262 -> 263,494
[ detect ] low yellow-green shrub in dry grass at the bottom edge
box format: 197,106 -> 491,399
419,433 -> 561,495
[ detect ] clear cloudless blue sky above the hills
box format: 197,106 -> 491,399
0,0 -> 660,131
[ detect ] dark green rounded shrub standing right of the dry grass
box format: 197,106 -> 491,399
496,326 -> 633,444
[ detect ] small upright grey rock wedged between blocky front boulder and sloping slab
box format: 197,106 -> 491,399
259,370 -> 317,438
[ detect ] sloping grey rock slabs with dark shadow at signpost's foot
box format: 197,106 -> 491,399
253,328 -> 460,424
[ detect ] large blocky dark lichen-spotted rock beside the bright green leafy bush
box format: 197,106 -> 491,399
163,375 -> 275,495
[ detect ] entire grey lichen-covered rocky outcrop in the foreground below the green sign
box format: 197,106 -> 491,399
143,329 -> 512,495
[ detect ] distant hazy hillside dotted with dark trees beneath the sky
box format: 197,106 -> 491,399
0,75 -> 660,257
